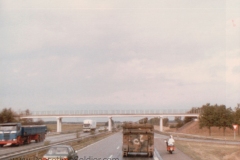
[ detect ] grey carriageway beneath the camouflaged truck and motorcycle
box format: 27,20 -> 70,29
78,132 -> 192,160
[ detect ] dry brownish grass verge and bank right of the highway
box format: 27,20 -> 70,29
156,122 -> 240,160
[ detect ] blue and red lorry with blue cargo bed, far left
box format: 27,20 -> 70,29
0,123 -> 47,147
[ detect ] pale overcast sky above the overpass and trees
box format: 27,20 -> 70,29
0,0 -> 240,111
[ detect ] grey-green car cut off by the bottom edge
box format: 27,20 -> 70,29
42,145 -> 78,160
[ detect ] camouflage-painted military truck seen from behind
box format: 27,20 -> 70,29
122,118 -> 154,157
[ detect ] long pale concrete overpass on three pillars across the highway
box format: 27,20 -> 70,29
20,109 -> 201,132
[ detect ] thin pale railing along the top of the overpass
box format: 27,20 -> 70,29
30,109 -> 201,115
